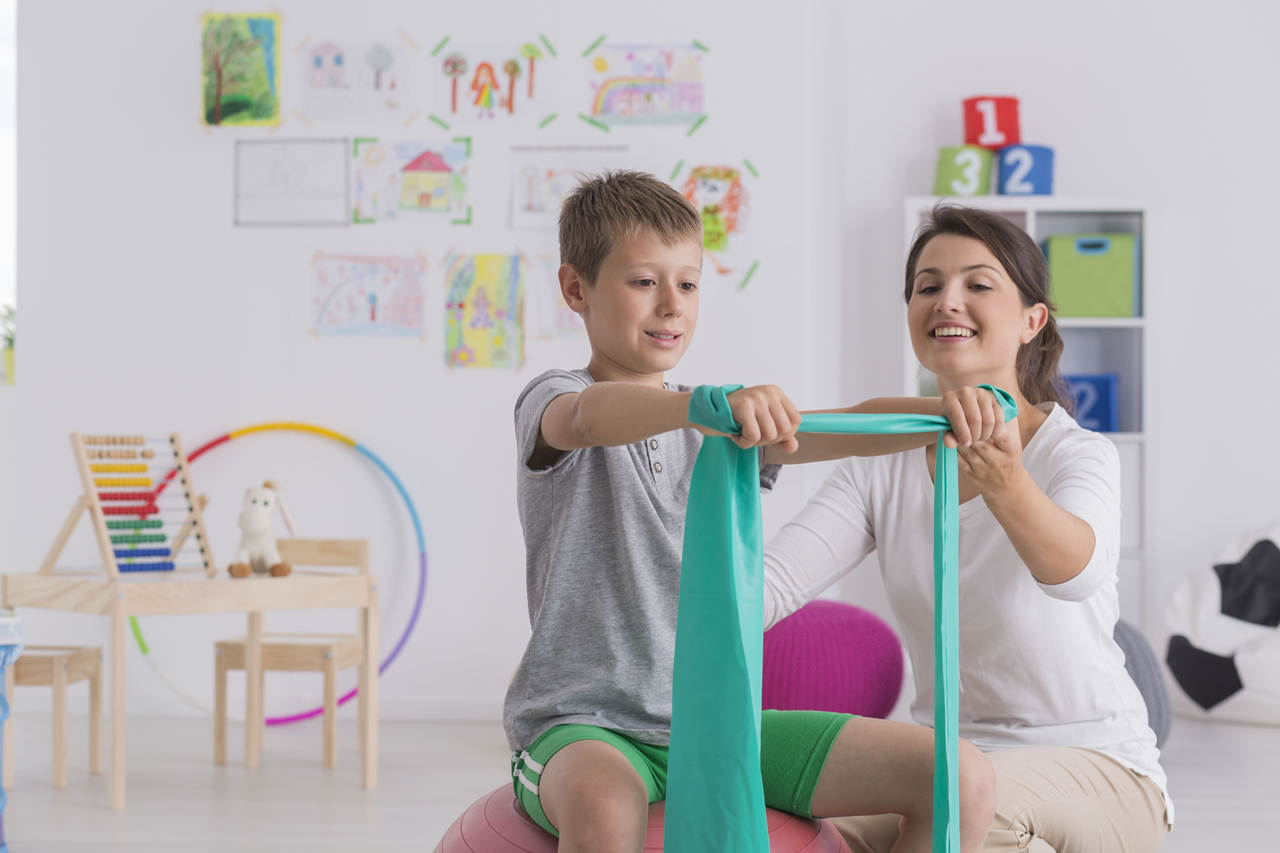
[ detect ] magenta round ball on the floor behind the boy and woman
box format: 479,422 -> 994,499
762,601 -> 902,720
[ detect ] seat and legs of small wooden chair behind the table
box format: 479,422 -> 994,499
214,634 -> 365,767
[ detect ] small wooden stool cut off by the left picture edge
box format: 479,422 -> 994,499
4,646 -> 102,788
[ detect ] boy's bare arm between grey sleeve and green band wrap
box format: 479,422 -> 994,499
572,382 -> 690,447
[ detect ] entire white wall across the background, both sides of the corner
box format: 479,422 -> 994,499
10,0 -> 1280,717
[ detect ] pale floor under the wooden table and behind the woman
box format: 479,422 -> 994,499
5,717 -> 1280,853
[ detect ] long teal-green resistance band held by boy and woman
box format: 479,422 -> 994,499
663,386 -> 1018,853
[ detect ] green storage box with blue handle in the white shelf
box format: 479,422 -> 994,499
1044,234 -> 1142,316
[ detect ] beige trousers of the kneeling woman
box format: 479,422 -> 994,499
832,747 -> 1169,853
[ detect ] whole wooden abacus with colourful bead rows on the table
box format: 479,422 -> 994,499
40,433 -> 216,579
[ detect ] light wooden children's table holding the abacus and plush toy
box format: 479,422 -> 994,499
0,570 -> 378,808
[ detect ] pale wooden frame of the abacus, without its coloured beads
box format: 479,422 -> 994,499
40,433 -> 218,580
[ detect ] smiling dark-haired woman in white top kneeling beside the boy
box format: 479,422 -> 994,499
765,206 -> 1172,853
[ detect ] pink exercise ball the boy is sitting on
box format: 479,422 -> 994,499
435,785 -> 850,853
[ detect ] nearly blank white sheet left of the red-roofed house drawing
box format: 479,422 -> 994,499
236,140 -> 348,225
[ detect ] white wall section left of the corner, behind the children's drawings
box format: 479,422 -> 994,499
13,0 -> 835,717
